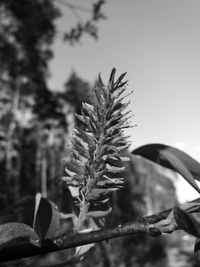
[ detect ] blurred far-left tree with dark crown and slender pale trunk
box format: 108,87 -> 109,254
0,0 -> 59,203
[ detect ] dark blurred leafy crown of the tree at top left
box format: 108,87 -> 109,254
0,0 -> 59,89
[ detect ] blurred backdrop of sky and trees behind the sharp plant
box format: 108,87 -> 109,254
0,0 -> 200,267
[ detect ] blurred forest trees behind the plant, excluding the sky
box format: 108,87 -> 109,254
0,0 -> 198,267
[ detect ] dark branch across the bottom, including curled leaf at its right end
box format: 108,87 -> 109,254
0,199 -> 200,262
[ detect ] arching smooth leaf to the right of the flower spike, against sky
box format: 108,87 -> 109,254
132,144 -> 200,193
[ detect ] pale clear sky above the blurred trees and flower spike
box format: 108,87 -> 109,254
49,0 -> 200,201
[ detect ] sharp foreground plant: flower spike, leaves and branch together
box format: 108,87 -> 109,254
0,66 -> 200,266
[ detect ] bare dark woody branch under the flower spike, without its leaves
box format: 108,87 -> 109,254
0,210 -> 171,262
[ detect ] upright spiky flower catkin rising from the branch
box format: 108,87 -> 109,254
62,68 -> 133,234
